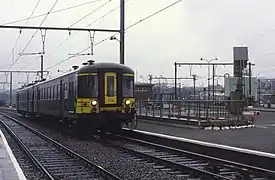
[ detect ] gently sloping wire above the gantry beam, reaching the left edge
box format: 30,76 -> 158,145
2,0 -> 103,25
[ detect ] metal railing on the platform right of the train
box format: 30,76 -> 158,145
136,100 -> 244,120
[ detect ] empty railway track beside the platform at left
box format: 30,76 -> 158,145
0,114 -> 120,180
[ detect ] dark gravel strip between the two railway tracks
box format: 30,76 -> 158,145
1,111 -> 185,180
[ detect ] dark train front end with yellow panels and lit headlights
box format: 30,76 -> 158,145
75,63 -> 136,130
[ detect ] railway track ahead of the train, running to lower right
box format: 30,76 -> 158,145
107,135 -> 275,180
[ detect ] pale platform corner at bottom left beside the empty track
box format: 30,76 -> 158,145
0,130 -> 26,180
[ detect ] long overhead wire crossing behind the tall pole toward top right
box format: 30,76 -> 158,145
46,0 -> 186,70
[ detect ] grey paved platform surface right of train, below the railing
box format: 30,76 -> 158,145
137,112 -> 275,154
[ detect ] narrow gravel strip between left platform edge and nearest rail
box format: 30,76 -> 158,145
0,124 -> 48,180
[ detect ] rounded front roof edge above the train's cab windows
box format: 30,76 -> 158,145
78,62 -> 134,74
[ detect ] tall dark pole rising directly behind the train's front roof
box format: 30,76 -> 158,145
119,0 -> 125,64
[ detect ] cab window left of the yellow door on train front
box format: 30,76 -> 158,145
77,75 -> 98,98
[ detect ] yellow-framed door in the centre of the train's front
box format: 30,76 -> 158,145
104,72 -> 117,105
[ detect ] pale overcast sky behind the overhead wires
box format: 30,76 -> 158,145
0,0 -> 275,87
